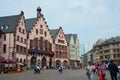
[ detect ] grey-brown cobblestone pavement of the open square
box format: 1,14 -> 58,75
0,69 -> 110,80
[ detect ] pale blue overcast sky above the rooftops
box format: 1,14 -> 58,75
0,0 -> 120,54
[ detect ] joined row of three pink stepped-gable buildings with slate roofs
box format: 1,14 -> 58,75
0,7 -> 79,68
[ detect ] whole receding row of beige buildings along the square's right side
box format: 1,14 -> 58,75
82,36 -> 120,66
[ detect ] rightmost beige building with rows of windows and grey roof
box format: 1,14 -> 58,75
94,36 -> 120,64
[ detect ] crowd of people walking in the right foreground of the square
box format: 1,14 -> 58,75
86,60 -> 119,80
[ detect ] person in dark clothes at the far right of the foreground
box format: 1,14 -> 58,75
108,61 -> 119,80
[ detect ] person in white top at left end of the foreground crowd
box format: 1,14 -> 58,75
86,61 -> 94,80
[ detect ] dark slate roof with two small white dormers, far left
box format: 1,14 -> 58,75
0,15 -> 20,33
